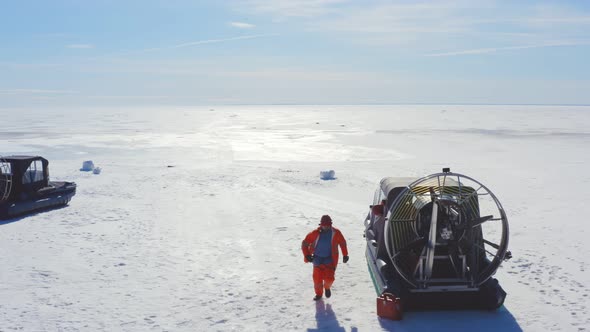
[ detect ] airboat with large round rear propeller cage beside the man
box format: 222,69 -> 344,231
364,168 -> 512,319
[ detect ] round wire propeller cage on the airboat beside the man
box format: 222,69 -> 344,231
382,172 -> 508,289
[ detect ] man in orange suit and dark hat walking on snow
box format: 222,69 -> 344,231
301,215 -> 348,301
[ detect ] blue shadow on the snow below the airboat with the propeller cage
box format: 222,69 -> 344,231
378,306 -> 522,332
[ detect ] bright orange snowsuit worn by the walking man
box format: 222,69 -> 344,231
301,227 -> 348,296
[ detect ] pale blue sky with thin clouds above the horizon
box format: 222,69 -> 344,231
0,0 -> 590,108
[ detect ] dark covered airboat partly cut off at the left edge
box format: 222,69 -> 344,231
0,156 -> 76,219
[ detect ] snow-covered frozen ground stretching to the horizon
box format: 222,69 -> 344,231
0,105 -> 590,331
